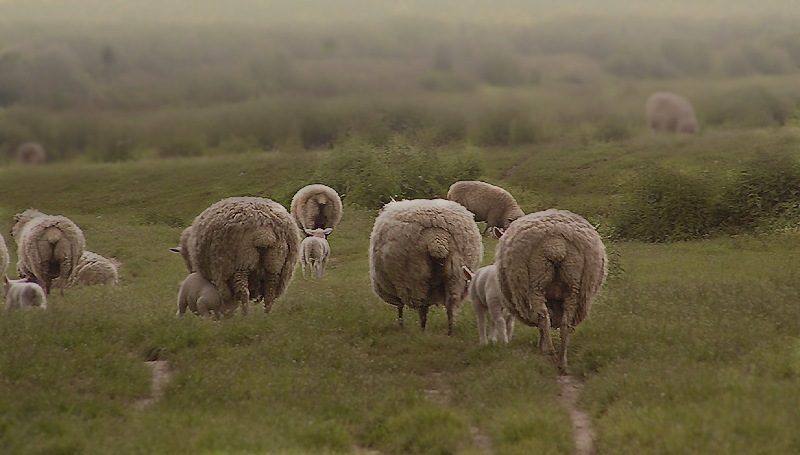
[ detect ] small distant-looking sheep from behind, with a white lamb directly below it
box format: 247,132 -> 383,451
290,184 -> 342,233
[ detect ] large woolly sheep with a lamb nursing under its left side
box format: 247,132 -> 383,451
192,197 -> 301,314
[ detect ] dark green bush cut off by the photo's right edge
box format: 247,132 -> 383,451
722,153 -> 800,230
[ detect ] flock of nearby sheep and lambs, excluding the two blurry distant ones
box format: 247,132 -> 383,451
0,181 -> 606,371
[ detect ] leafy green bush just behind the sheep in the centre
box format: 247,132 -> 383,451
317,137 -> 481,209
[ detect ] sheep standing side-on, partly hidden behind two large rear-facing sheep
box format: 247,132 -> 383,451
447,180 -> 525,235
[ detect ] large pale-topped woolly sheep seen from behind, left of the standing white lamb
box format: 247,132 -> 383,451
369,199 -> 483,335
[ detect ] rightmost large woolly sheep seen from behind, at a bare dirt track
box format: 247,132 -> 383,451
495,209 -> 607,373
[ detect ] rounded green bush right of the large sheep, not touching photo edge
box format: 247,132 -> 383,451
614,165 -> 720,242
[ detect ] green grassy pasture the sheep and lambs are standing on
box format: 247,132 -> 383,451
0,136 -> 800,454
